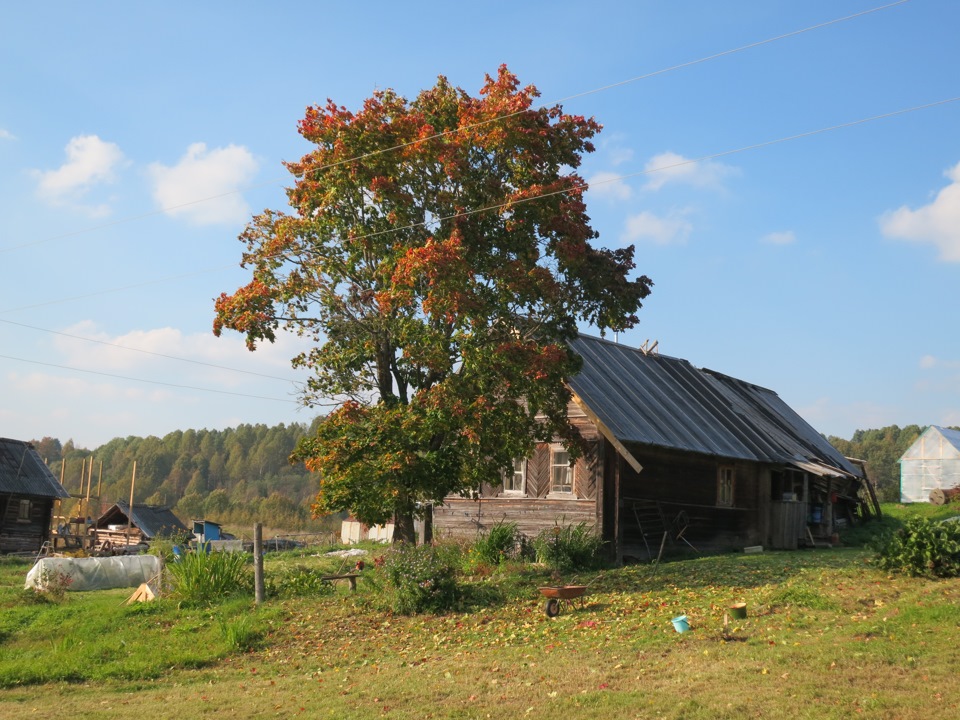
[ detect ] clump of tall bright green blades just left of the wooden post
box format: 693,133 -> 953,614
166,552 -> 253,604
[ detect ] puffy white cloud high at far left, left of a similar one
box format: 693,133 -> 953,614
34,135 -> 124,216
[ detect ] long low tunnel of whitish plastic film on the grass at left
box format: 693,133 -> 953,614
24,555 -> 162,591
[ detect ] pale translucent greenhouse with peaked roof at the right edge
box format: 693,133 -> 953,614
900,425 -> 960,503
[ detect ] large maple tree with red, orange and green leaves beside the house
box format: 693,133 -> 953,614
214,67 -> 652,541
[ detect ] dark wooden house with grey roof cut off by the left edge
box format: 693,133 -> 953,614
0,438 -> 70,553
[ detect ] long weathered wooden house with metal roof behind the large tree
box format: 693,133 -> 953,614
433,336 -> 871,560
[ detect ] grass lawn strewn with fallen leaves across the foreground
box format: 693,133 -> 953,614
0,509 -> 960,720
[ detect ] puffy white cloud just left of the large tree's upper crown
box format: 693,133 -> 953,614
149,143 -> 257,225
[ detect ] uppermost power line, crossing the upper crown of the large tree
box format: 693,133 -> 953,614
0,0 -> 910,255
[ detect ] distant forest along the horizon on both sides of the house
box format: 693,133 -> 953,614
32,423 -> 960,532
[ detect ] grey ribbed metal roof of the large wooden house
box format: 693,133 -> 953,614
569,335 -> 862,477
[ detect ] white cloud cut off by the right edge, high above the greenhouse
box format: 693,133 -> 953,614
880,163 -> 960,262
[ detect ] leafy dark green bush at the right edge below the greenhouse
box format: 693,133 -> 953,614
875,517 -> 960,577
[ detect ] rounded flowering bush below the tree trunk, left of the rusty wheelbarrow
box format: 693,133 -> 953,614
384,545 -> 460,615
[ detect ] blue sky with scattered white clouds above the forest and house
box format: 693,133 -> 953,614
0,0 -> 960,448
